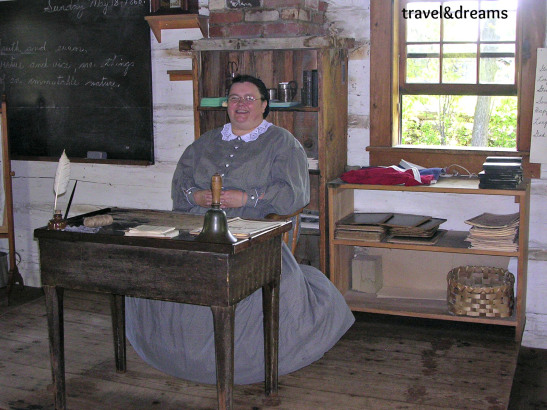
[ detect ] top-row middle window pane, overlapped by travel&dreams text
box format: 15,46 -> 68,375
443,1 -> 479,41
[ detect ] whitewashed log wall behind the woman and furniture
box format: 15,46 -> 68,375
0,0 -> 547,348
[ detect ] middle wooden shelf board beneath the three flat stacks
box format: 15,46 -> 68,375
333,231 -> 519,257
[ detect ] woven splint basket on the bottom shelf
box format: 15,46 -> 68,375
447,266 -> 515,317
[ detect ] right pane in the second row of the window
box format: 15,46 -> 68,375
479,44 -> 515,84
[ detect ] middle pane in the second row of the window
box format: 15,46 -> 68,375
442,44 -> 477,84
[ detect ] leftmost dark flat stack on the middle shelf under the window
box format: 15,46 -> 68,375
334,212 -> 393,242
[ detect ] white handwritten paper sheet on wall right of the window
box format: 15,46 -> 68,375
530,48 -> 547,163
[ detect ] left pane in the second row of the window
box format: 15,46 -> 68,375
406,44 -> 440,84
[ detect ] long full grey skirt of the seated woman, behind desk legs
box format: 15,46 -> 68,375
126,244 -> 355,384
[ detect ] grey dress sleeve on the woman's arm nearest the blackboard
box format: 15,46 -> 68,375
171,144 -> 197,212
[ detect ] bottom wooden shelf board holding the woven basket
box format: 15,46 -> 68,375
344,290 -> 517,327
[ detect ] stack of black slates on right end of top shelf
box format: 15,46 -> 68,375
479,157 -> 522,189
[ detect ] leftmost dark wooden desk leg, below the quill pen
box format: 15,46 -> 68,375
44,286 -> 66,409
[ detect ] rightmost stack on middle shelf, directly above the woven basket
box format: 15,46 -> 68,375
465,212 -> 520,252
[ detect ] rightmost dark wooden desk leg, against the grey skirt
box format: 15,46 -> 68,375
262,279 -> 279,396
